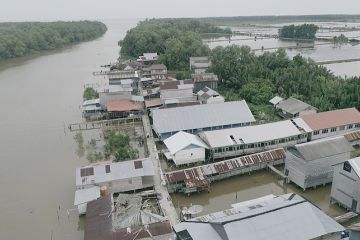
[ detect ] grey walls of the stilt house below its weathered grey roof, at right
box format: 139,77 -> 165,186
285,152 -> 350,190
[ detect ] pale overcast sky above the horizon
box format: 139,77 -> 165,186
0,0 -> 360,21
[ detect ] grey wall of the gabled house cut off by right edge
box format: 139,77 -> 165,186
330,163 -> 360,213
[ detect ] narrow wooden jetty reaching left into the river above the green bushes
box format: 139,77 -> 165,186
68,116 -> 141,132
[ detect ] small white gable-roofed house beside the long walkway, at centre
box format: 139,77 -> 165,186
164,131 -> 208,166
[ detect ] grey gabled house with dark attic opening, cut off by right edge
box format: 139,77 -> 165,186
331,157 -> 360,213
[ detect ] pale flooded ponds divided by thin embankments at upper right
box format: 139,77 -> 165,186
207,22 -> 360,77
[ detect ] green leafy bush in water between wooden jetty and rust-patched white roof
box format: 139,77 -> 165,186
104,130 -> 138,162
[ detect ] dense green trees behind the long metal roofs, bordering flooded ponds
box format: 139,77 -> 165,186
211,45 -> 360,112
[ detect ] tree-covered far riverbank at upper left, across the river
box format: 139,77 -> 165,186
0,21 -> 107,60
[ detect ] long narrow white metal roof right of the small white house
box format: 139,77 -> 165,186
200,120 -> 301,148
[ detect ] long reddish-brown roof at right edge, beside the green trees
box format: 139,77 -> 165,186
302,108 -> 360,131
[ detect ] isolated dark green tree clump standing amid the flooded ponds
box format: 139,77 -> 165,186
279,24 -> 319,39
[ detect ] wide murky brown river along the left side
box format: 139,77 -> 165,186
0,20 -> 137,240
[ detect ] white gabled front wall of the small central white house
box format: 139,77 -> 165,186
173,146 -> 205,165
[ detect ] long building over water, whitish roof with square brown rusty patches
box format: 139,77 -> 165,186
76,158 -> 155,193
